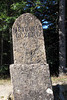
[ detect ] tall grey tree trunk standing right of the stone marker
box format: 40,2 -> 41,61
59,0 -> 66,75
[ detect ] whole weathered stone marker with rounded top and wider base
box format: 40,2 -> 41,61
10,13 -> 53,100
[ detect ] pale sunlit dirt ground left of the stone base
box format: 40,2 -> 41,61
0,79 -> 12,100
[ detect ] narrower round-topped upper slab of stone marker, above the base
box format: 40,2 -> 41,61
12,13 -> 46,64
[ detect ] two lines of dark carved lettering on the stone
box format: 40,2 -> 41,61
13,25 -> 42,39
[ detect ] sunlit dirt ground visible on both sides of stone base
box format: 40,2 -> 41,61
0,76 -> 67,100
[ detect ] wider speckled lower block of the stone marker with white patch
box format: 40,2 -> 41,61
10,64 -> 54,100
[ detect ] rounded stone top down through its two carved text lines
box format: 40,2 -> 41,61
12,13 -> 43,39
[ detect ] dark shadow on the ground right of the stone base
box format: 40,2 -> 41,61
53,84 -> 67,100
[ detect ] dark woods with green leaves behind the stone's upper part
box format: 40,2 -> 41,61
0,0 -> 58,76
